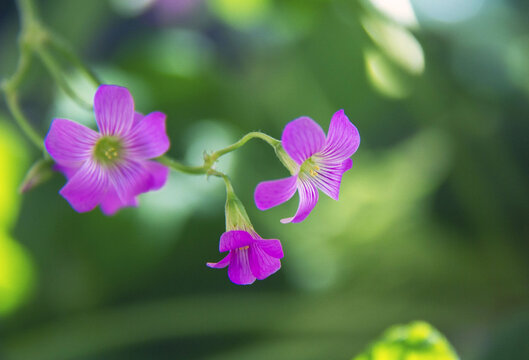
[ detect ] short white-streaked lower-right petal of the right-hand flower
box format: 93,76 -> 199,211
311,158 -> 353,200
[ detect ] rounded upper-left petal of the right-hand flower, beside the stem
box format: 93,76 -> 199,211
281,117 -> 325,165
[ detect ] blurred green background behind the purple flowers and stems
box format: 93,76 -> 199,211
0,0 -> 529,360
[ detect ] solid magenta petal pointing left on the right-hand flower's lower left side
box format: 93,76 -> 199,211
254,176 -> 297,210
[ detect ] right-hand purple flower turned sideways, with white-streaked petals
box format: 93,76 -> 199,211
254,110 -> 360,223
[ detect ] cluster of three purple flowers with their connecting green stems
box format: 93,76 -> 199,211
44,85 -> 360,285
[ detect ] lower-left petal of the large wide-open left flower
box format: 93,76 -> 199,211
59,160 -> 108,212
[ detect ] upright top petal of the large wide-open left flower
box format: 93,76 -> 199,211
94,85 -> 134,135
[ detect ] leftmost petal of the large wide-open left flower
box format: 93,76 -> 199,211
44,119 -> 99,167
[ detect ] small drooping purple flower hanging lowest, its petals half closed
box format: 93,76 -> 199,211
207,230 -> 283,285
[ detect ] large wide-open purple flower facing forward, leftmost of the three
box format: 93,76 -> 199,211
44,85 -> 169,215
